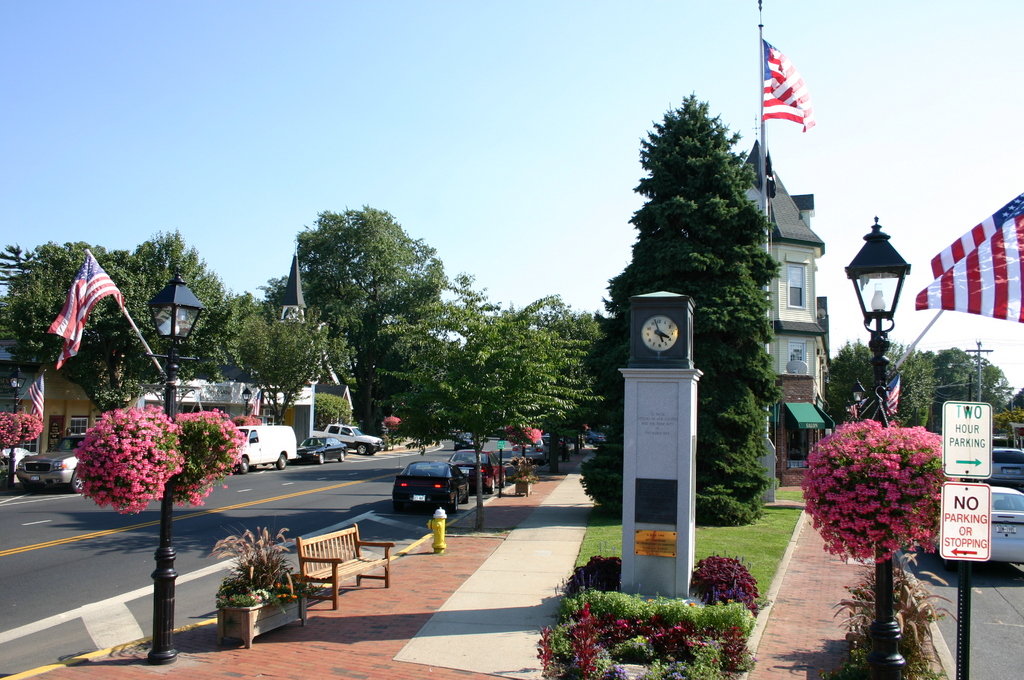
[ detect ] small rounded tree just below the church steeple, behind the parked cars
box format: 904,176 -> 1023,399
233,309 -> 331,422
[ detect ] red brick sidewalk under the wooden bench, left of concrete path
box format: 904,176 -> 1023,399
15,460 -> 579,680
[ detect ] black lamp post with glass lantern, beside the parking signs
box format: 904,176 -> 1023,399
846,217 -> 910,680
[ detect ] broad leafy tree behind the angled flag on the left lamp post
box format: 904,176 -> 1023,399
0,232 -> 231,411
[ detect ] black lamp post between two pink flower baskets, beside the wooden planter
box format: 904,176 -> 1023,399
147,273 -> 204,666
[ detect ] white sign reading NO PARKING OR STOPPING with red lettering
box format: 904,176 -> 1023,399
939,481 -> 992,562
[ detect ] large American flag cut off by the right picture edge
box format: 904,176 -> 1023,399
916,189 -> 1024,323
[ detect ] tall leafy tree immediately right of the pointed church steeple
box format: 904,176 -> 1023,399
298,207 -> 445,432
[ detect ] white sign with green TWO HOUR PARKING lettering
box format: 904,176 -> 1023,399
942,401 -> 992,479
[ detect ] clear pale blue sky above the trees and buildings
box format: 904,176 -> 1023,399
6,0 -> 1024,389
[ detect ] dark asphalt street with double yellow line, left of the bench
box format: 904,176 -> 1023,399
0,451 -> 464,677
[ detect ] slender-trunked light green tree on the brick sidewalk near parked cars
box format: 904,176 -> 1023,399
400,277 -> 583,529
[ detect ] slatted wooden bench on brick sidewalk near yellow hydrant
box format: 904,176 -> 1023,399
295,524 -> 394,609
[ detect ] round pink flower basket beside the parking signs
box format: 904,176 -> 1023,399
803,420 -> 944,561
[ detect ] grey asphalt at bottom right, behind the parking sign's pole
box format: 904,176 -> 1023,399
916,554 -> 1024,680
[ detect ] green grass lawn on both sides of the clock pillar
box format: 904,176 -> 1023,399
577,495 -> 802,595
